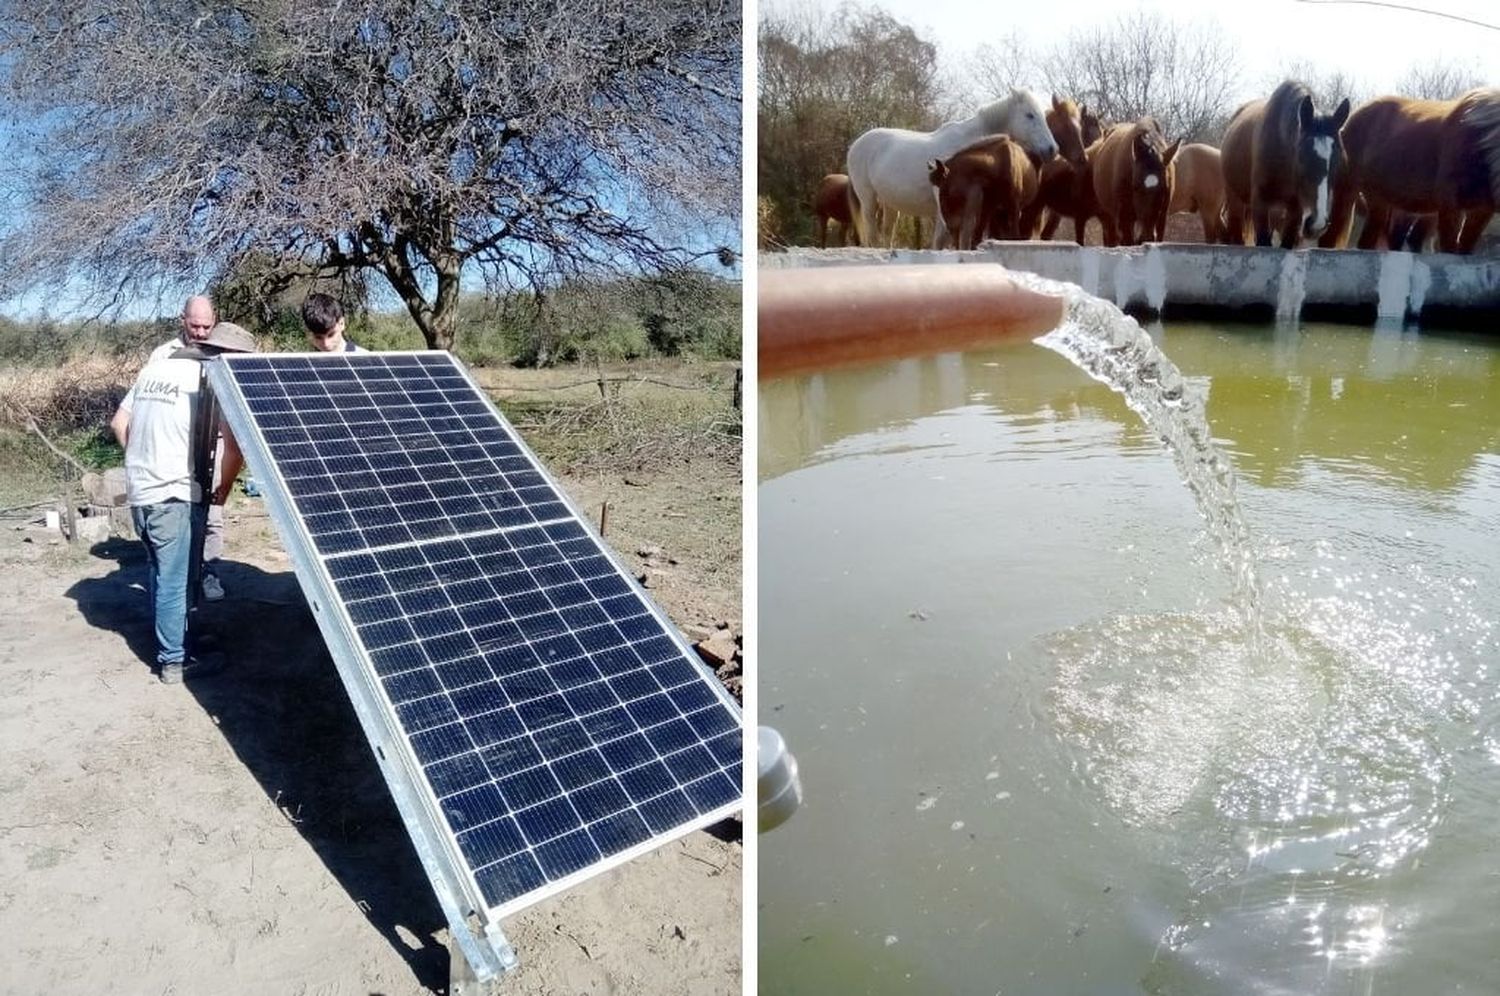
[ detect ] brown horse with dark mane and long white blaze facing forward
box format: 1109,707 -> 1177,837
1220,80 -> 1349,249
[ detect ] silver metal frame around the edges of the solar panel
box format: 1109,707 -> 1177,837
206,351 -> 744,981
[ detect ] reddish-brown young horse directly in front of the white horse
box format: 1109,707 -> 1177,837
927,135 -> 1037,249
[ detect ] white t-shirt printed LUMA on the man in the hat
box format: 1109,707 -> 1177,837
120,354 -> 203,506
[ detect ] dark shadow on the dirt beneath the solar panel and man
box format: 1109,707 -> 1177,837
68,539 -> 449,992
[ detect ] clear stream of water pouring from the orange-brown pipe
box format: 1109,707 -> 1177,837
1011,273 -> 1262,633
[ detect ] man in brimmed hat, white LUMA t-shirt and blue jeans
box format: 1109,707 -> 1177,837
110,323 -> 255,684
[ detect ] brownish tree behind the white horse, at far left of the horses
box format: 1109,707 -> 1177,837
758,5 -> 941,242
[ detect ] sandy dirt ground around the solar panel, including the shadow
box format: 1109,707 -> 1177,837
0,464 -> 741,996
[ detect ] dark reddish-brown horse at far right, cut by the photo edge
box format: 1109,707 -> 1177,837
1319,87 -> 1500,254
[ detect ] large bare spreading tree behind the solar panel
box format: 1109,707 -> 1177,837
0,0 -> 741,348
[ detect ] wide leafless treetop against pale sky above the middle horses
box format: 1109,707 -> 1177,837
1043,11 -> 1241,141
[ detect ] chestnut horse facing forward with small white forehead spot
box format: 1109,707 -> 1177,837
1080,117 -> 1182,246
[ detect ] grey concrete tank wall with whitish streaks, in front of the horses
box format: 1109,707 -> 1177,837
761,242 -> 1500,330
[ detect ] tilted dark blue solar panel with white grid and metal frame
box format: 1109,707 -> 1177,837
209,353 -> 741,978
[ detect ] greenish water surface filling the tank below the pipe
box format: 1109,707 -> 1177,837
759,326 -> 1500,995
